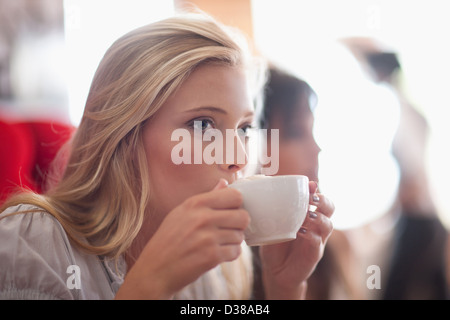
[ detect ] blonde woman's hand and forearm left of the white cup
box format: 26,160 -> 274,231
116,179 -> 250,299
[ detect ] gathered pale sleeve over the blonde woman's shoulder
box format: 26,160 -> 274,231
0,204 -> 79,299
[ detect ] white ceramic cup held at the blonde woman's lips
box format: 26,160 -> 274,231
229,175 -> 309,246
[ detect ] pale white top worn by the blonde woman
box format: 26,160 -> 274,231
0,205 -> 126,300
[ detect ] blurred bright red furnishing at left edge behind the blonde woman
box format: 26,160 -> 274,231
0,119 -> 75,203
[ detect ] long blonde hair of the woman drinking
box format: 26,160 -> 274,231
2,14 -> 259,298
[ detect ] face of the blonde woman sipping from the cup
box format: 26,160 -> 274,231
143,64 -> 254,216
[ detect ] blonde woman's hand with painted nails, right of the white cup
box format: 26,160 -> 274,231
260,182 -> 334,299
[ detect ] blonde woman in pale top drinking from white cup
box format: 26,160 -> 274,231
0,15 -> 334,299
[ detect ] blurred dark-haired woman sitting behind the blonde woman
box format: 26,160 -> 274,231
254,66 -> 362,299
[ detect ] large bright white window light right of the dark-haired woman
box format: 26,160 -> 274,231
252,0 -> 450,229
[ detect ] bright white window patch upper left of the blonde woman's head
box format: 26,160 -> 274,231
64,0 -> 174,125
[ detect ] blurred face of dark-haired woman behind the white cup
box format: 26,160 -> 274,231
273,107 -> 320,181
